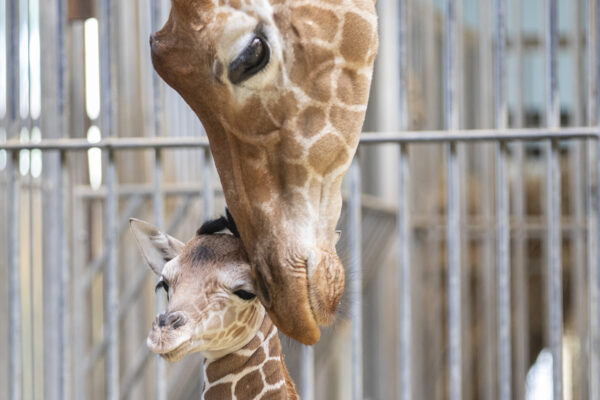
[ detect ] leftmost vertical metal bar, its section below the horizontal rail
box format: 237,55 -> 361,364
7,151 -> 23,400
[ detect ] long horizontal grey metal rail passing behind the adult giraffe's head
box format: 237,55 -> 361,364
0,127 -> 600,151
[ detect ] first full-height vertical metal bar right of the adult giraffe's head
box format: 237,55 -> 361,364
396,0 -> 413,400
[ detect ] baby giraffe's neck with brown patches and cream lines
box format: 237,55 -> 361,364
202,313 -> 298,400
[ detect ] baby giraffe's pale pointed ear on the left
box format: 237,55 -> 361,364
129,218 -> 183,275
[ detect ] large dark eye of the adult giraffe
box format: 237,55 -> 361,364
229,34 -> 271,85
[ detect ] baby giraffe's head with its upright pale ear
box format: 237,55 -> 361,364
130,219 -> 265,362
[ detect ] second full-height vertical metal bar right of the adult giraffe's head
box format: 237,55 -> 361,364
444,0 -> 462,400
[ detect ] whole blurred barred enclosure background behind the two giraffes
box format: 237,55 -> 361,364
0,0 -> 600,399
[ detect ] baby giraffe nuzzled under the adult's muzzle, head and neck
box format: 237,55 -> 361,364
130,213 -> 298,400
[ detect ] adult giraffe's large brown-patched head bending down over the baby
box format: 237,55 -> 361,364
150,0 -> 377,344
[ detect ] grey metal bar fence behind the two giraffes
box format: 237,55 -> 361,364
0,0 -> 600,400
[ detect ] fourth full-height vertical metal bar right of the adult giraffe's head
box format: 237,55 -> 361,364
546,0 -> 563,400
